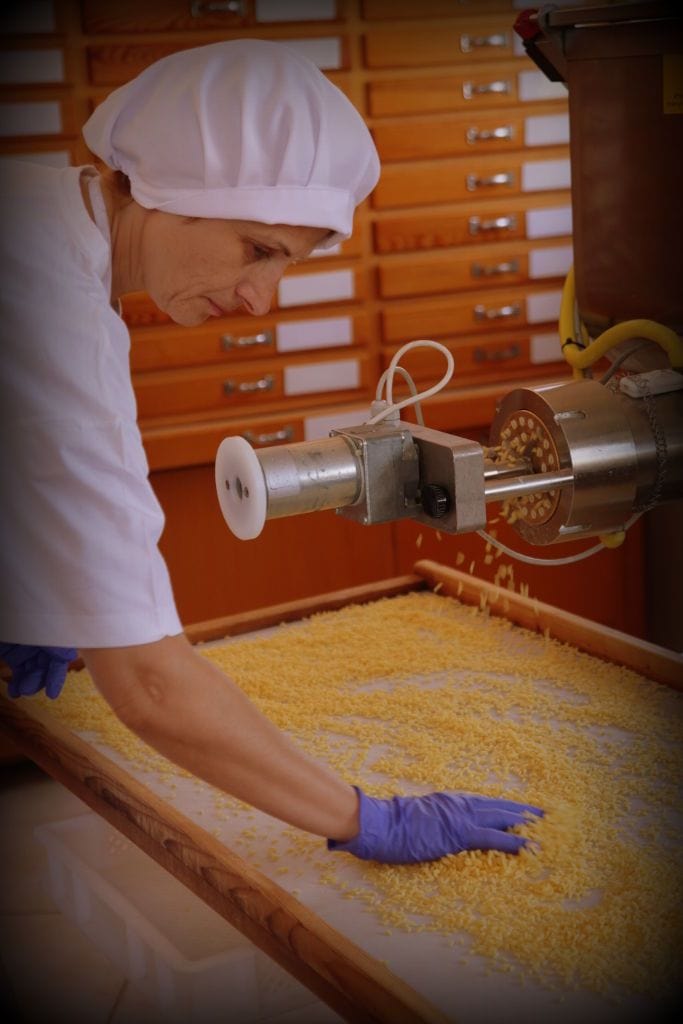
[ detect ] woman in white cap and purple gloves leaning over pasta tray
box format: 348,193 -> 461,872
0,40 -> 541,862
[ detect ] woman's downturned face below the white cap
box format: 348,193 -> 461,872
141,211 -> 330,327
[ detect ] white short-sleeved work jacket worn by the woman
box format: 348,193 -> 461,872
0,161 -> 182,647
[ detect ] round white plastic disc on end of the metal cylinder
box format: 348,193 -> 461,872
216,437 -> 267,541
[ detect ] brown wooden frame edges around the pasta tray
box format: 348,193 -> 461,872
0,560 -> 683,1024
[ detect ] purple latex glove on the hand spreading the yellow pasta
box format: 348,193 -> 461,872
328,786 -> 543,864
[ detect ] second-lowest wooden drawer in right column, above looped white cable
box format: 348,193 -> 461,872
381,286 -> 560,344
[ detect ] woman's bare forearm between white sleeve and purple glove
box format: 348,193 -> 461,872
82,636 -> 359,840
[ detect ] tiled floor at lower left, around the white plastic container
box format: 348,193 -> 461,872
0,762 -> 340,1024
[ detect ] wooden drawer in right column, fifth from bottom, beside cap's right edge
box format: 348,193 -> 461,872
372,147 -> 570,210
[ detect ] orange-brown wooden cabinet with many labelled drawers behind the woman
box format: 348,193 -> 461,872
0,0 -> 651,630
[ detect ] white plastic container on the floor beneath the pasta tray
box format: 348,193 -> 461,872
35,814 -> 322,1024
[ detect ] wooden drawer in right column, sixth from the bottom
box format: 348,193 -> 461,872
373,103 -> 569,162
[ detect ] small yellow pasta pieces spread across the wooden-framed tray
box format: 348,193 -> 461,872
36,593 -> 683,1001
